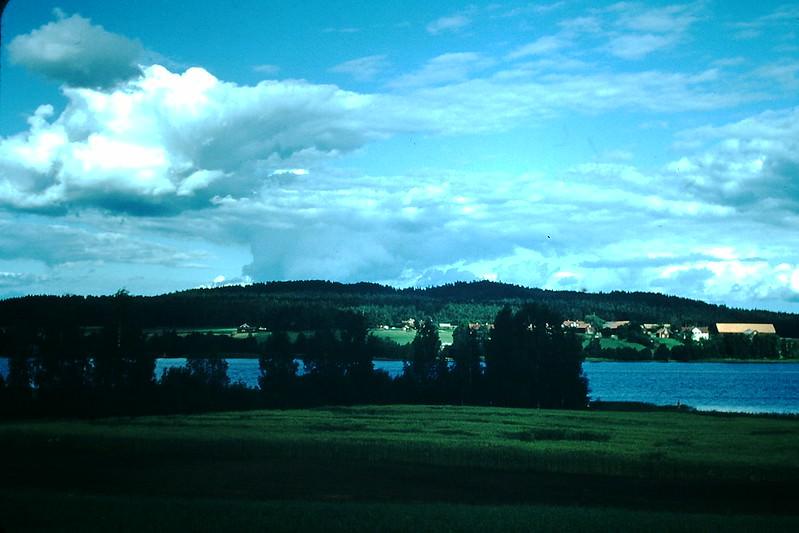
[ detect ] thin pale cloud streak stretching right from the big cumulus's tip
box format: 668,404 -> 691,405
396,66 -> 761,133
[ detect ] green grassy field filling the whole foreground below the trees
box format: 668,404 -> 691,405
0,406 -> 799,532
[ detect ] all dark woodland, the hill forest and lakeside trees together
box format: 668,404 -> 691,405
0,282 -> 796,417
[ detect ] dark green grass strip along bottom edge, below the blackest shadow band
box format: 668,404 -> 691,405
0,491 -> 799,533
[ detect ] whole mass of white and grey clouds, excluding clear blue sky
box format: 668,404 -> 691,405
0,3 -> 799,312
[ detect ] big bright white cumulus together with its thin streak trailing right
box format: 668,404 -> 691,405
0,21 -> 772,215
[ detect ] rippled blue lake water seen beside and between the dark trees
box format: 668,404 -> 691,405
0,358 -> 799,414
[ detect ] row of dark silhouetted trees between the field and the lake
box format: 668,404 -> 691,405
0,292 -> 588,417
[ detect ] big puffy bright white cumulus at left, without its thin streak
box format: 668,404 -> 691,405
0,62 -> 396,214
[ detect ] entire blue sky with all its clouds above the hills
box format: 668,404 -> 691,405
0,0 -> 799,312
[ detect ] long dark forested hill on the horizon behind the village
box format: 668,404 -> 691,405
0,281 -> 799,337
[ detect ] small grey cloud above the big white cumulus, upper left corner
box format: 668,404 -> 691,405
8,11 -> 143,89
